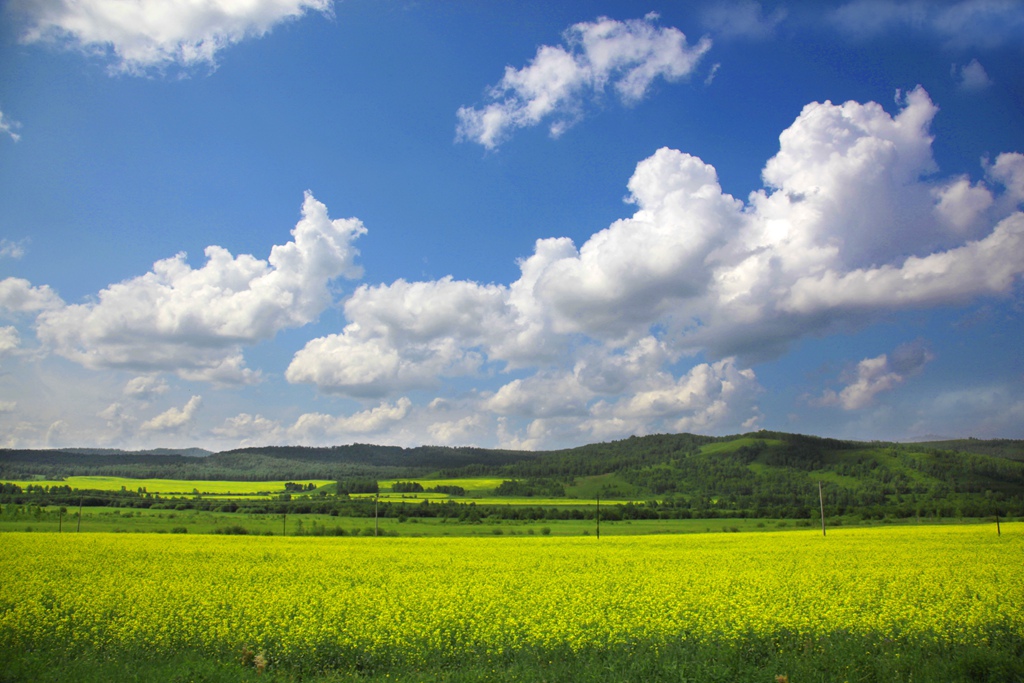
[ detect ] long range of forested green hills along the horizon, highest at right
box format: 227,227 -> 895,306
0,431 -> 1024,510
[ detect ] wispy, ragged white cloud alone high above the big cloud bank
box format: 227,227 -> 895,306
457,14 -> 711,150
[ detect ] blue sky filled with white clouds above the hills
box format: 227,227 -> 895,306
0,0 -> 1024,450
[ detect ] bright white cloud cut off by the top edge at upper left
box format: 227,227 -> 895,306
16,0 -> 333,73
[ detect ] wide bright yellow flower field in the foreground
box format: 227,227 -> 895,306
0,523 -> 1024,663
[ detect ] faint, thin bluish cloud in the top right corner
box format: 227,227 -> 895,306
830,0 -> 1024,48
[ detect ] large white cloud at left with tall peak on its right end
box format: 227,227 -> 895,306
30,193 -> 366,384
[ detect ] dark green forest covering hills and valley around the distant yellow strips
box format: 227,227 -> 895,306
0,431 -> 1024,519
